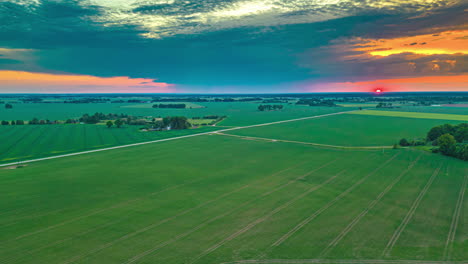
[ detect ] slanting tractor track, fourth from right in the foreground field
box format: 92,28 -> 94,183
271,153 -> 398,247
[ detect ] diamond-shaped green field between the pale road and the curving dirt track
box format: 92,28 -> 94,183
227,114 -> 460,146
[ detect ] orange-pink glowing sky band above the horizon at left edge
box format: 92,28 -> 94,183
0,70 -> 173,93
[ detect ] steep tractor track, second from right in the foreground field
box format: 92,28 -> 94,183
382,164 -> 442,256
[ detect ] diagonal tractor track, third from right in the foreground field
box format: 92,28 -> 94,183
320,154 -> 422,256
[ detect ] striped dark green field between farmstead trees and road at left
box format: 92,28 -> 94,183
0,124 -> 215,163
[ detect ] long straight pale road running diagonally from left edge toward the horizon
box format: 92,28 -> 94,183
0,110 -> 352,167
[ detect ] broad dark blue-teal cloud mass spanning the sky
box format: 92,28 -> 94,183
0,0 -> 468,91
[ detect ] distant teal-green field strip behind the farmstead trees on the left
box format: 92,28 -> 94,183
0,102 -> 353,126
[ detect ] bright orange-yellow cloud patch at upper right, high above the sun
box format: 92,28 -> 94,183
354,30 -> 468,56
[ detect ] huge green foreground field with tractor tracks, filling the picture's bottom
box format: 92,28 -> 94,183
0,135 -> 468,264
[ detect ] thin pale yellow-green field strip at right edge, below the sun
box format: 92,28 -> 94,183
349,110 -> 468,122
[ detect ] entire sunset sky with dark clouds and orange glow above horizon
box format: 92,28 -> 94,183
0,0 -> 468,93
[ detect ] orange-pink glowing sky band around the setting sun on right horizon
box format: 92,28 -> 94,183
305,74 -> 468,92
